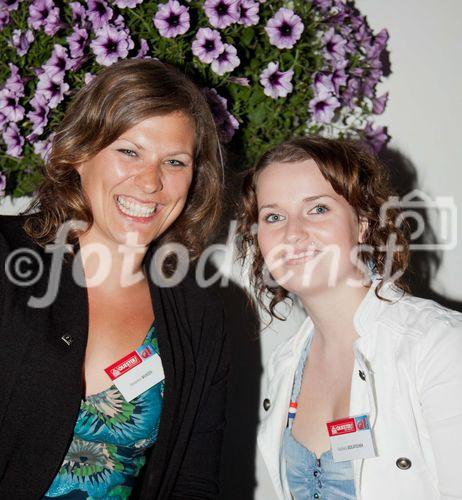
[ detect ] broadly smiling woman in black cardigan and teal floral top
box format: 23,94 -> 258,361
0,60 -> 228,499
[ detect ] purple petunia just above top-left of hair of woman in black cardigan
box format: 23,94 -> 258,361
90,25 -> 133,66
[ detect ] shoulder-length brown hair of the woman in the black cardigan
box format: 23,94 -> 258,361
24,59 -> 223,260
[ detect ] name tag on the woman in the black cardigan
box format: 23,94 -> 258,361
104,345 -> 165,401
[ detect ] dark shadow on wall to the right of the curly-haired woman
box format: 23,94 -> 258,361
379,148 -> 462,312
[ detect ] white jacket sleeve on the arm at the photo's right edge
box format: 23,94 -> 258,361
417,315 -> 462,500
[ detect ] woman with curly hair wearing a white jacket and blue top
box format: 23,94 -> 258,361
238,137 -> 462,500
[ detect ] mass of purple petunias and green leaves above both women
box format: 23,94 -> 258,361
0,0 -> 388,196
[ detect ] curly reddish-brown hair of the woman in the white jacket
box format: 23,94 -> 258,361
237,137 -> 409,319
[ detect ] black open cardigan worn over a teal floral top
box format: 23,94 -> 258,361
0,216 -> 228,500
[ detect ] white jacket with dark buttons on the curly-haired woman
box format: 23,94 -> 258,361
258,280 -> 462,500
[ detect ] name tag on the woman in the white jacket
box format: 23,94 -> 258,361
327,415 -> 376,462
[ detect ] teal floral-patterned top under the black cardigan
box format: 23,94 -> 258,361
45,324 -> 164,500
